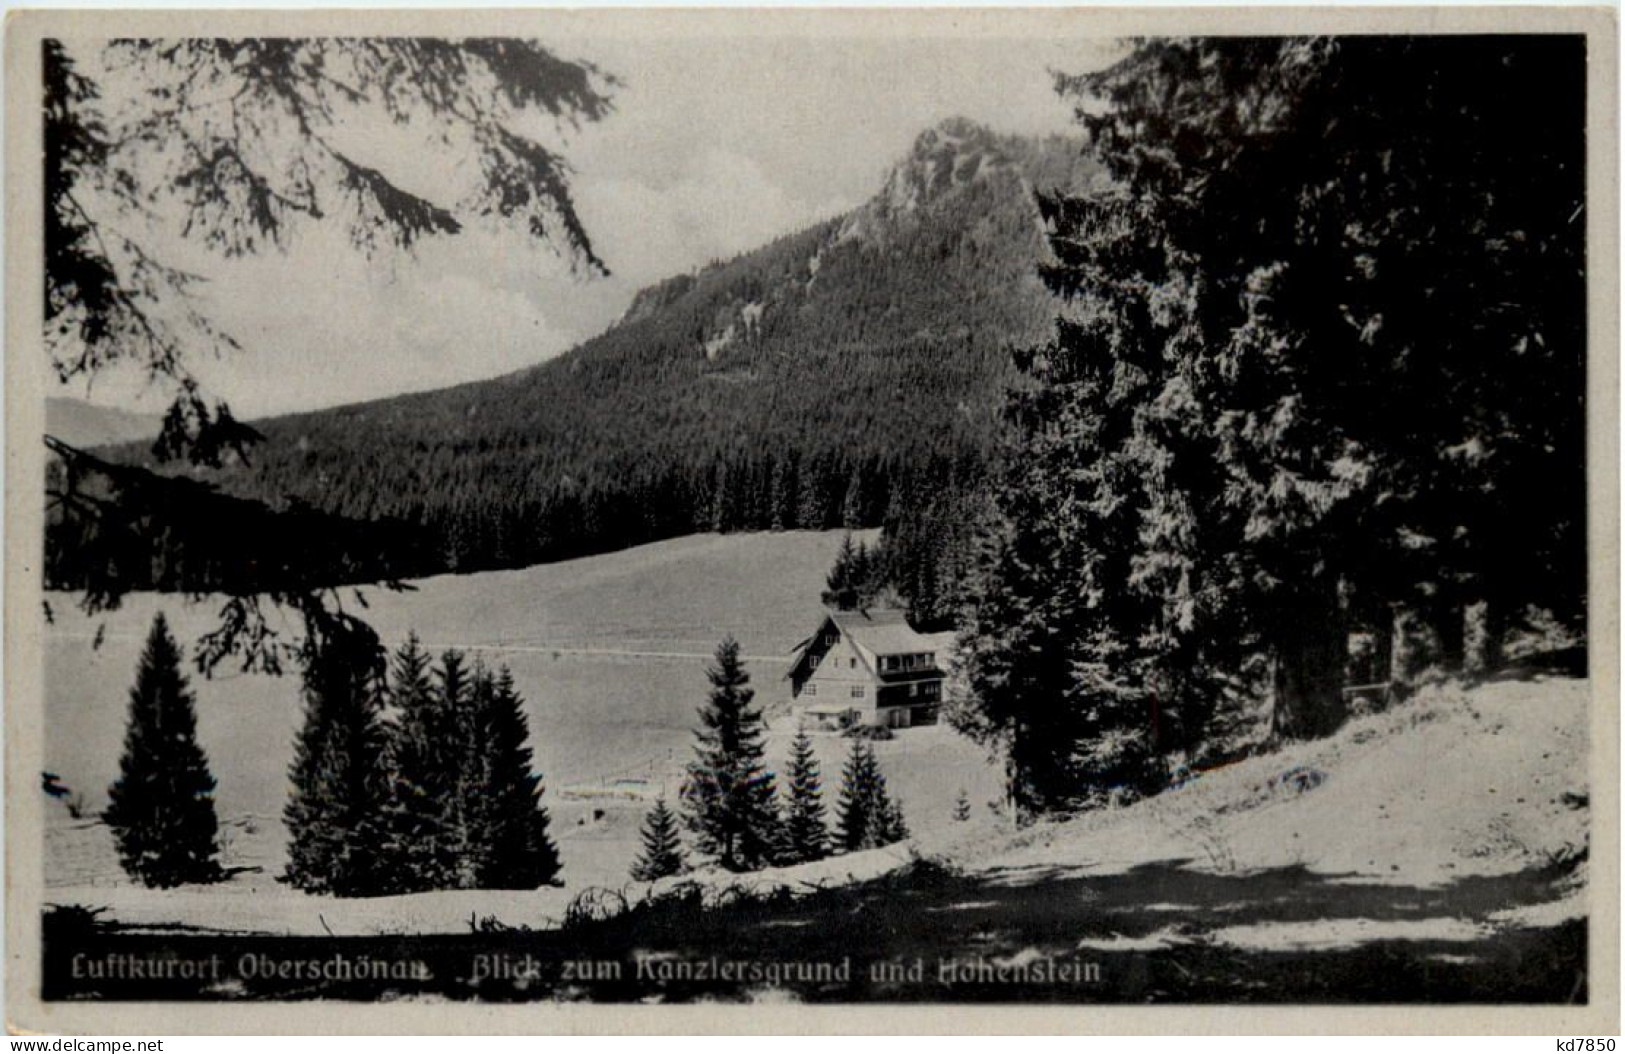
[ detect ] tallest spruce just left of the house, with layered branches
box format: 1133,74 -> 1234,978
683,637 -> 778,870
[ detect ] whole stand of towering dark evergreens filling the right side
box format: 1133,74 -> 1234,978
954,37 -> 1584,812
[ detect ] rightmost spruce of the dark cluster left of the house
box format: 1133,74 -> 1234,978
465,667 -> 559,890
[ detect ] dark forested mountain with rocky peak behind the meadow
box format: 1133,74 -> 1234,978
92,120 -> 1099,620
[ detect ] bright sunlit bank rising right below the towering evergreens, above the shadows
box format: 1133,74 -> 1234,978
975,677 -> 1591,887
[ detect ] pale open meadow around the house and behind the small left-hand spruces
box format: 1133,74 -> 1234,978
44,531 -> 998,934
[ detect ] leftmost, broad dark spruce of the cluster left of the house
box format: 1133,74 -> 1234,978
283,630 -> 393,896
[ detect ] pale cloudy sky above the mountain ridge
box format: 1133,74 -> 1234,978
63,24 -> 1115,417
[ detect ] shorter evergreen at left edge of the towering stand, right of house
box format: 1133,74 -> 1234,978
949,448 -> 1159,815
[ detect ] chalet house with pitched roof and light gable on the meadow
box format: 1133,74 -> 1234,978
787,609 -> 949,729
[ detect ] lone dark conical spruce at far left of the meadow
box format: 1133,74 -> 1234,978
102,614 -> 221,888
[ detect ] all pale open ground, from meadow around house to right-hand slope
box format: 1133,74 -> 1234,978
42,516 -> 1589,947
